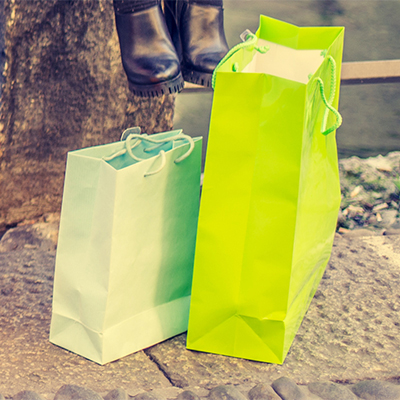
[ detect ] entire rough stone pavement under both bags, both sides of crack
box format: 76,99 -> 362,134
0,223 -> 400,399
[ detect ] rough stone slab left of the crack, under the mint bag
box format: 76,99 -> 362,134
0,245 -> 172,399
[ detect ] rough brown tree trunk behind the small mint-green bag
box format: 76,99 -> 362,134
0,0 -> 175,230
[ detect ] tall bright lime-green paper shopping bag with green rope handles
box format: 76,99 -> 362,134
187,16 -> 344,364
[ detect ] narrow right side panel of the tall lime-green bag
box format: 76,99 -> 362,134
284,27 -> 344,355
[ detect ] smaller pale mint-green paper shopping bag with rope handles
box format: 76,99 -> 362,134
50,128 -> 201,364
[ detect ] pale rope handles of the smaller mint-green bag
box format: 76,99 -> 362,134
103,132 -> 195,177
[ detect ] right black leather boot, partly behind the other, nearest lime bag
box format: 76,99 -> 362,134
164,0 -> 229,87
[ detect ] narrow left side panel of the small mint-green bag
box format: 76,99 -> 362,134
50,152 -> 115,363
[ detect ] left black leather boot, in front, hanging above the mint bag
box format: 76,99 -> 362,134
115,4 -> 184,97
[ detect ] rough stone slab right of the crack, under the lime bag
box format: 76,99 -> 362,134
148,235 -> 400,388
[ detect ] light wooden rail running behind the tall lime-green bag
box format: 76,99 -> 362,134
183,60 -> 400,93
